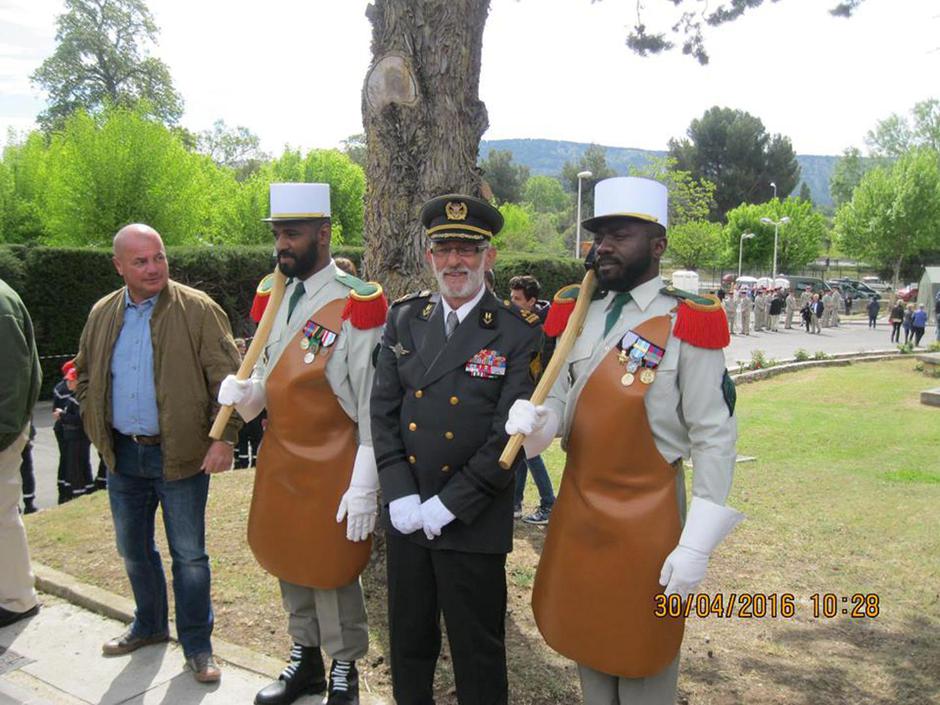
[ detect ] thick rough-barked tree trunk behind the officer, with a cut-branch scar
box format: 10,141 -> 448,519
362,0 -> 489,296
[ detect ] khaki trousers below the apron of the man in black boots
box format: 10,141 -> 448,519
279,578 -> 369,661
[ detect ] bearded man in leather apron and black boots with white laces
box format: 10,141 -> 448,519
219,183 -> 387,705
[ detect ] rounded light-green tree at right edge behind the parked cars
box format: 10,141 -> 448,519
835,149 -> 940,281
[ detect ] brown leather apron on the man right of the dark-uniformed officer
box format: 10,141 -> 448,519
532,316 -> 685,678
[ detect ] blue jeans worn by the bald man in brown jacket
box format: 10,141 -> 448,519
108,434 -> 214,658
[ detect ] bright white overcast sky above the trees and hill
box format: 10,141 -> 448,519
0,0 -> 940,154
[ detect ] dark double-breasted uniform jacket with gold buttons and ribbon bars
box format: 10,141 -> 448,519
371,291 -> 541,553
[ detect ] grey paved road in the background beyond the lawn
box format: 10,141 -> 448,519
22,319 -> 936,509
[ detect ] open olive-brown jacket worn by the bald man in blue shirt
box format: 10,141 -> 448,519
75,280 -> 241,480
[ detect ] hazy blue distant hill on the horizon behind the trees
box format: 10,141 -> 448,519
480,139 -> 838,208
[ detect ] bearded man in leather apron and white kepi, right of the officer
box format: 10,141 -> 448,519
506,177 -> 740,705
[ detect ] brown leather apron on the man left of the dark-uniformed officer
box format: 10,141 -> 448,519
248,299 -> 372,589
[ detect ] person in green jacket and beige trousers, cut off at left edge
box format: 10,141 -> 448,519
0,279 -> 42,627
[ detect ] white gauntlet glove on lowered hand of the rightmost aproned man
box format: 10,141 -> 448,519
659,497 -> 744,600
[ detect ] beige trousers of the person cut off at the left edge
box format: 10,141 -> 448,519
0,425 -> 37,612
